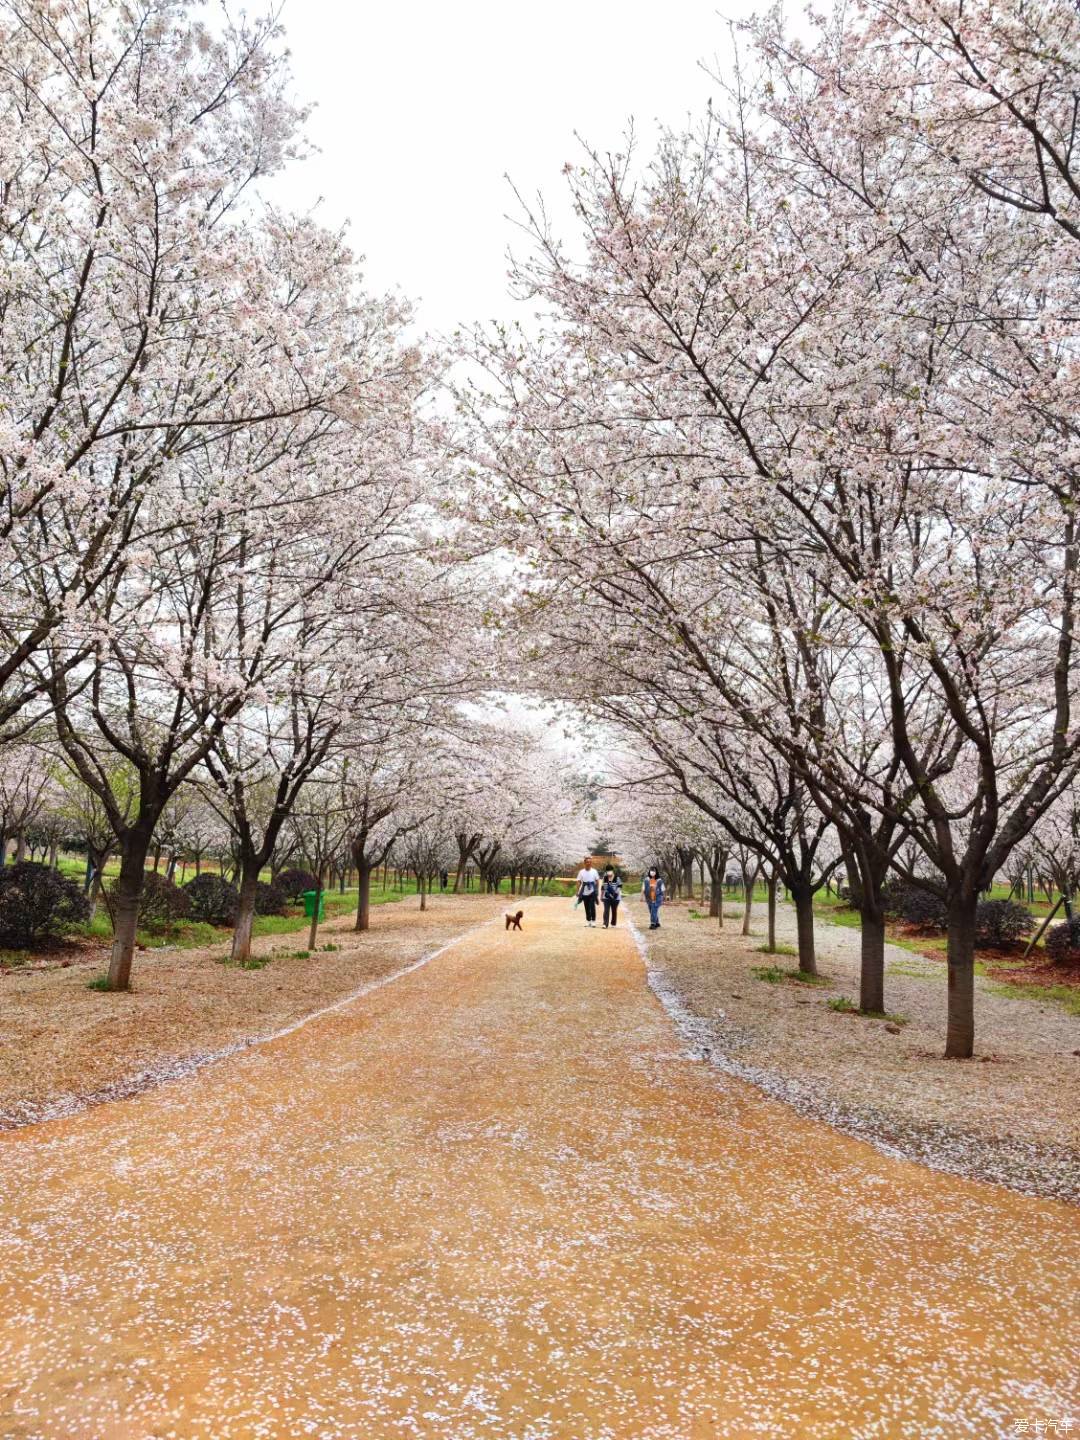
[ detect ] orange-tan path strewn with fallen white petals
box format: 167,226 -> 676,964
0,900 -> 1080,1440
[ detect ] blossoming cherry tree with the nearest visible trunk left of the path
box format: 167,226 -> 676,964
39,347 -> 426,988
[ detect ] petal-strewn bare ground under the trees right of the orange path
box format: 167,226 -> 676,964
649,901 -> 1080,1203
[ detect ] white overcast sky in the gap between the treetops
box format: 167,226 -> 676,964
272,0 -> 763,333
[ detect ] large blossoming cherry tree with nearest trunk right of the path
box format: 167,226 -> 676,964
464,11 -> 1080,1057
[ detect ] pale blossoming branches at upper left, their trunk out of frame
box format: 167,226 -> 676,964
0,0 -> 319,724
